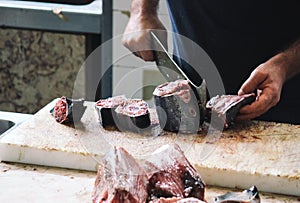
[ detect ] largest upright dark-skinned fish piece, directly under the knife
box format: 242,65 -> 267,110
153,80 -> 204,133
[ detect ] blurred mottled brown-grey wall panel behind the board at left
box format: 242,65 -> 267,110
0,29 -> 85,113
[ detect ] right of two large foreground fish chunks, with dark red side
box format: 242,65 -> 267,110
144,144 -> 205,201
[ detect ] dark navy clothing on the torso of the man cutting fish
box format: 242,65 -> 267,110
167,0 -> 300,124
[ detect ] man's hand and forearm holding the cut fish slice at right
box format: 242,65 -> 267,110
238,40 -> 300,120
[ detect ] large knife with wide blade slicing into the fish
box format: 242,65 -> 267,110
151,32 -> 206,104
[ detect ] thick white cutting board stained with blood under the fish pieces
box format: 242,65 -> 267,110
0,100 -> 300,196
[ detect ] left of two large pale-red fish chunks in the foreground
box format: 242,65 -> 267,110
92,147 -> 148,203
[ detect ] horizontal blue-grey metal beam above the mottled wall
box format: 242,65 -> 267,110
0,0 -> 103,34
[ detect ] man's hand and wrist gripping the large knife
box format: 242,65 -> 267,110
122,0 -> 167,61
